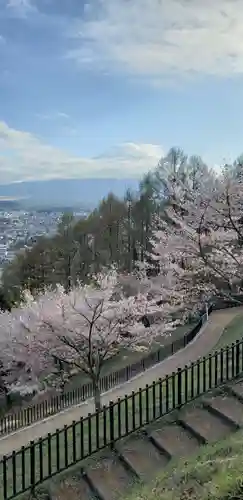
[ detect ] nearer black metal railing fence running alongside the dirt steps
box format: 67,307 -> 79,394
0,339 -> 243,500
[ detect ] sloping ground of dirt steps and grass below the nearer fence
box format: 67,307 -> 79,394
23,379 -> 243,500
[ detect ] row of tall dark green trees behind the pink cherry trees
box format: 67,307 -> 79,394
2,148 -> 220,302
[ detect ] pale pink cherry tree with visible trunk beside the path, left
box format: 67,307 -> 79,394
0,268 -> 182,409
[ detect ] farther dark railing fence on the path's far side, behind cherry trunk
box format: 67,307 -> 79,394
0,307 -> 212,435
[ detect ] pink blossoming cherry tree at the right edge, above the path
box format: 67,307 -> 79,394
150,161 -> 243,307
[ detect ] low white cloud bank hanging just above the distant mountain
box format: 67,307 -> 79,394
0,122 -> 163,184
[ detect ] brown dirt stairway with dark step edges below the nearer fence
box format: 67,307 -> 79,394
42,379 -> 243,500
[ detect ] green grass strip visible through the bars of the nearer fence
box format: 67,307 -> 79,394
0,346 -> 242,498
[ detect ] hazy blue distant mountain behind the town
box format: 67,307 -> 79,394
0,179 -> 139,208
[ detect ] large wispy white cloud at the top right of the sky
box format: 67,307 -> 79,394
68,0 -> 243,81
